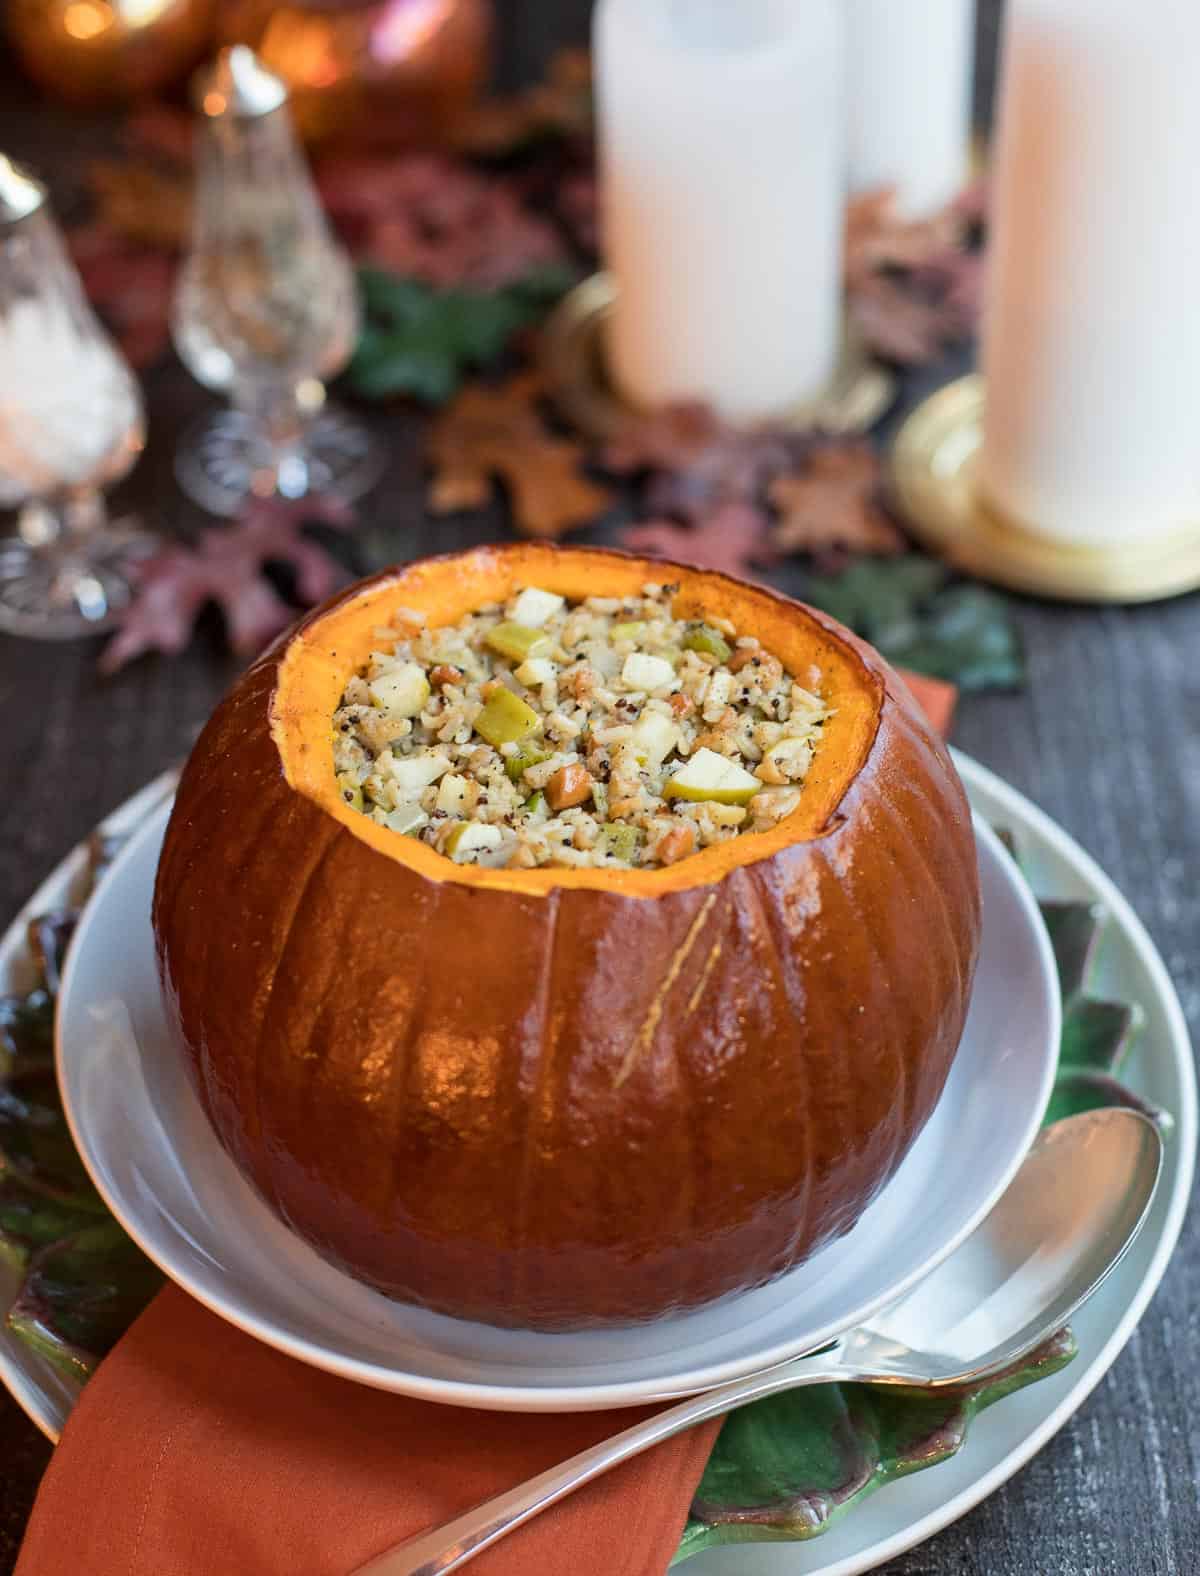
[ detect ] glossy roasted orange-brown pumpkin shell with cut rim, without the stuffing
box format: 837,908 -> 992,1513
153,544 -> 979,1329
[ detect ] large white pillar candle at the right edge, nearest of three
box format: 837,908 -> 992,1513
979,0 -> 1200,544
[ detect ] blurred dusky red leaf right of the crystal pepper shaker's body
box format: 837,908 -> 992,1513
317,154 -> 566,290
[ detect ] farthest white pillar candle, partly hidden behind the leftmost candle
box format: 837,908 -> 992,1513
845,0 -> 975,217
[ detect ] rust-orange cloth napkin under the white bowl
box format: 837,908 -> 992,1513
16,673 -> 956,1576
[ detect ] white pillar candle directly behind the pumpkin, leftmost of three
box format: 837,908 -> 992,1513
596,0 -> 845,421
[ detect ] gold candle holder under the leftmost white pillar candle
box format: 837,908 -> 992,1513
542,273 -> 896,440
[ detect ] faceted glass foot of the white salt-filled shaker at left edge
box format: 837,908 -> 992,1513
0,523 -> 158,640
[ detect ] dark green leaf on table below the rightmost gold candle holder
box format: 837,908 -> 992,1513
804,553 -> 1025,690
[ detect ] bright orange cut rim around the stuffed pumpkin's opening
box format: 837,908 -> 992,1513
271,542 -> 885,898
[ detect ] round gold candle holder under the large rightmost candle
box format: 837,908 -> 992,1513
891,375 -> 1200,604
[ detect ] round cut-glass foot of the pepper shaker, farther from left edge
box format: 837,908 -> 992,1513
175,405 -> 383,514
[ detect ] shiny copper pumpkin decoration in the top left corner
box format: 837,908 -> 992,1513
6,0 -> 214,109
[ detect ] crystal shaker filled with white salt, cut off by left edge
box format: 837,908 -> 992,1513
0,154 -> 148,640
